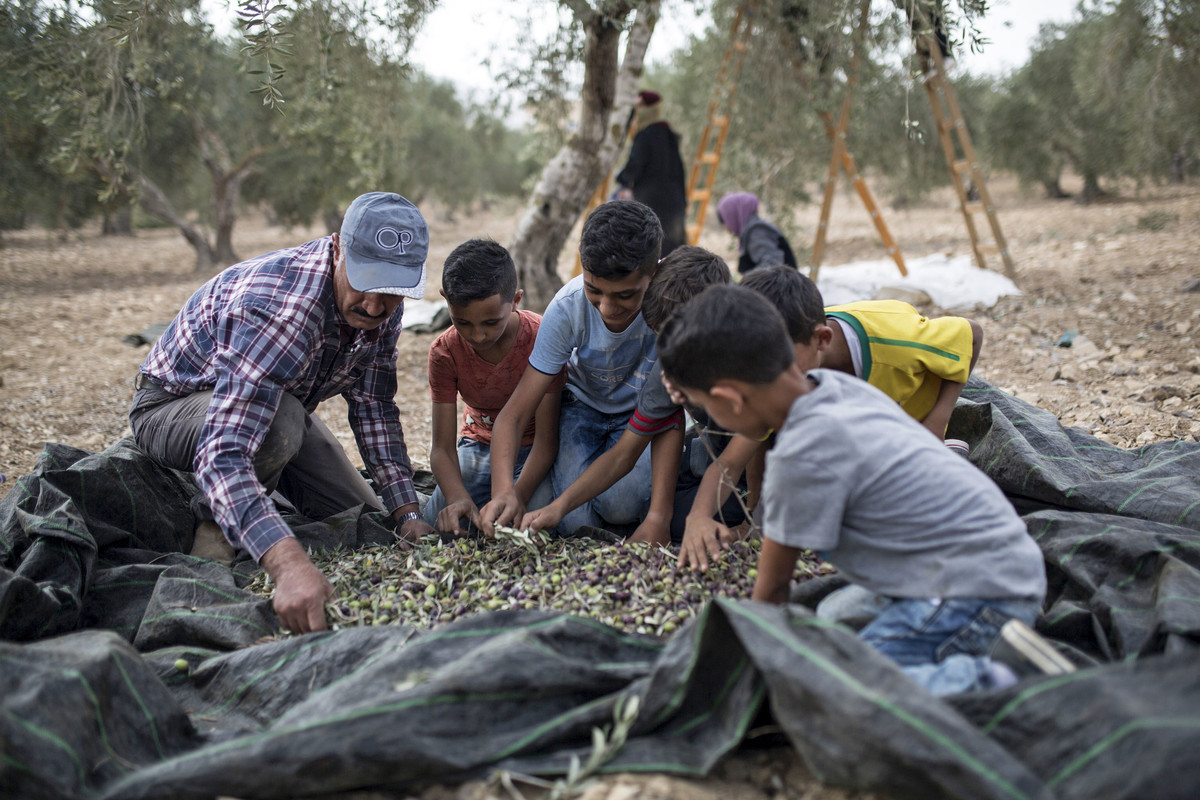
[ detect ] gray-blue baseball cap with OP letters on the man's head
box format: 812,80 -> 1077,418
341,192 -> 430,300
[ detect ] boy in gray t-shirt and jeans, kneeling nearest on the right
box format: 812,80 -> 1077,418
659,287 -> 1046,694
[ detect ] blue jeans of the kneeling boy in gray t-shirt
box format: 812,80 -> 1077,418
858,597 -> 1042,697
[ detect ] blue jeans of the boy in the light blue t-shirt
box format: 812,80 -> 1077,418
550,390 -> 650,535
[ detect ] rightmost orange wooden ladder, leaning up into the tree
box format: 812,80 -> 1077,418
917,33 -> 1016,283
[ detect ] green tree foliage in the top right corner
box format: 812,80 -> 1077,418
989,0 -> 1200,200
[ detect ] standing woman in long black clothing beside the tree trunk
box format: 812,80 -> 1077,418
617,89 -> 688,257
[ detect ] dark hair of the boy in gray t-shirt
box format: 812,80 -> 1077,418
659,285 -> 796,392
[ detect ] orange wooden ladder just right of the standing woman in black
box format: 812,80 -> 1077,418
688,0 -> 755,245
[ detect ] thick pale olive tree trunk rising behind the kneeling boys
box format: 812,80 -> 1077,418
509,0 -> 661,311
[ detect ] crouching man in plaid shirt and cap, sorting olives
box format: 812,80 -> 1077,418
130,192 -> 431,632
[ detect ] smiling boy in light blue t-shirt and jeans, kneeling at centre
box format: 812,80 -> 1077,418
480,200 -> 662,534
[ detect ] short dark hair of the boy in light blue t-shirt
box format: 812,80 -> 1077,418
580,200 -> 662,281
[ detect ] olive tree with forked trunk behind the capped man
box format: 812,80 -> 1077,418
9,0 -> 432,271
